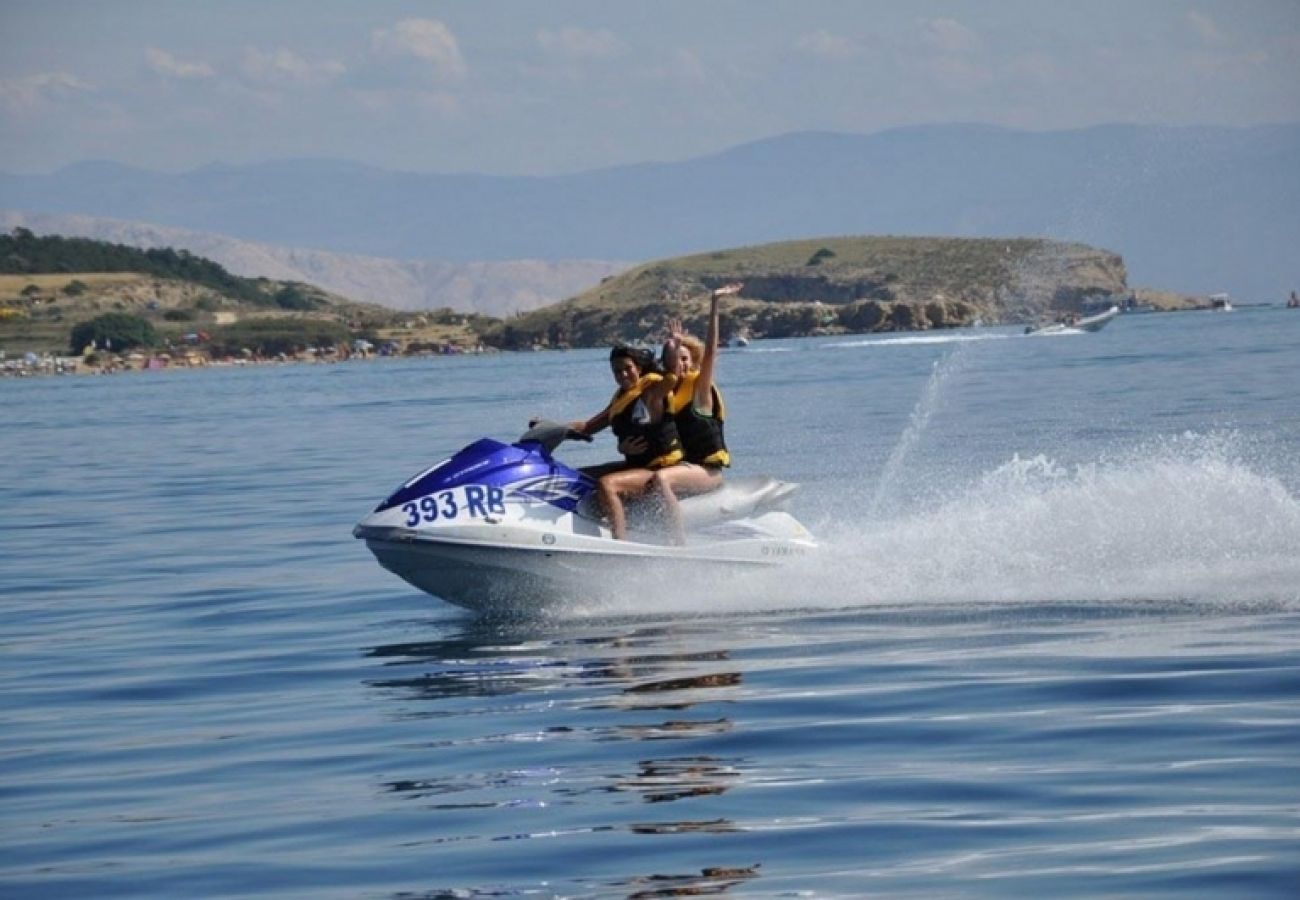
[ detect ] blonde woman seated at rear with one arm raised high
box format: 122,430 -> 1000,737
651,284 -> 742,544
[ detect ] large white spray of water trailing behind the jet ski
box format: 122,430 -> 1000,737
564,431 -> 1300,615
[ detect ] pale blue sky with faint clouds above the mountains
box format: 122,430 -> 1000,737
0,0 -> 1300,174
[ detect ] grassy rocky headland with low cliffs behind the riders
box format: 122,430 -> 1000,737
490,237 -> 1128,347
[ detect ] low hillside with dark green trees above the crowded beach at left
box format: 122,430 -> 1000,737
0,228 -> 495,358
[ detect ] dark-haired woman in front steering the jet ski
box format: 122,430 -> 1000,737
573,345 -> 683,540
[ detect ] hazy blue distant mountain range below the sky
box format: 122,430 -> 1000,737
0,125 -> 1300,300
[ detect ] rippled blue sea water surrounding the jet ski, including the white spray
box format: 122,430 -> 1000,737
0,308 -> 1300,897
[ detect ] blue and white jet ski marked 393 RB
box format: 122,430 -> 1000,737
352,421 -> 816,613
